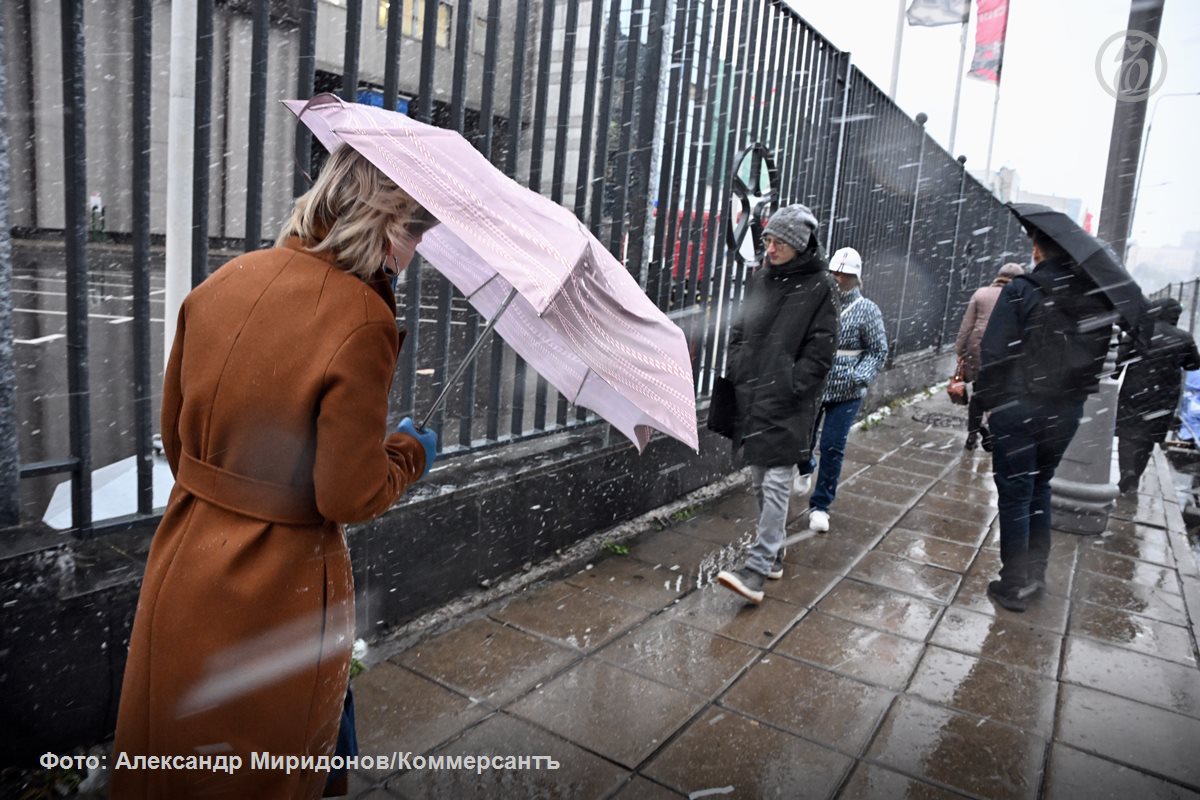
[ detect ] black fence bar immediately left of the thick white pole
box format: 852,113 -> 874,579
130,0 -> 154,513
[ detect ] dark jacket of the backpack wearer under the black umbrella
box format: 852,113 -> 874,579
974,259 -> 1112,410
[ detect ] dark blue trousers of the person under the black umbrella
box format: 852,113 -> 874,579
991,398 -> 1084,588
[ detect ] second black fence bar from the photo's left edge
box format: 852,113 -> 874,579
61,0 -> 91,530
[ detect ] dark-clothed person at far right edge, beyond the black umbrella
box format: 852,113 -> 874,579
1117,297 -> 1200,494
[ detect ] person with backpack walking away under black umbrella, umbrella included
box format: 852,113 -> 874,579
976,204 -> 1146,612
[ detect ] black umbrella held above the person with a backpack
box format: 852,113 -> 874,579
1008,203 -> 1148,331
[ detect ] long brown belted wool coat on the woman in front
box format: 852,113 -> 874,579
112,240 -> 425,800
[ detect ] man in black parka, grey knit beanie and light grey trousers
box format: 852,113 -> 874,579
716,204 -> 838,603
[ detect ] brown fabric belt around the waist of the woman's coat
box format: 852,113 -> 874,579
175,452 -> 325,525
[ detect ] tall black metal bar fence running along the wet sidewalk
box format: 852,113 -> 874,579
0,0 -> 1026,533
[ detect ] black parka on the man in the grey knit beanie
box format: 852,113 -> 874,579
726,247 -> 838,467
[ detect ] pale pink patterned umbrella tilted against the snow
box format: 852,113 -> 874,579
284,95 -> 700,452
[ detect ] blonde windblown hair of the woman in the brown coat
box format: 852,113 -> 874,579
276,145 -> 436,281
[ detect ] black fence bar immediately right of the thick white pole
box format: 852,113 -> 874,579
192,0 -> 212,287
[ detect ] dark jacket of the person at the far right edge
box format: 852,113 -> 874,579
1117,300 -> 1200,443
